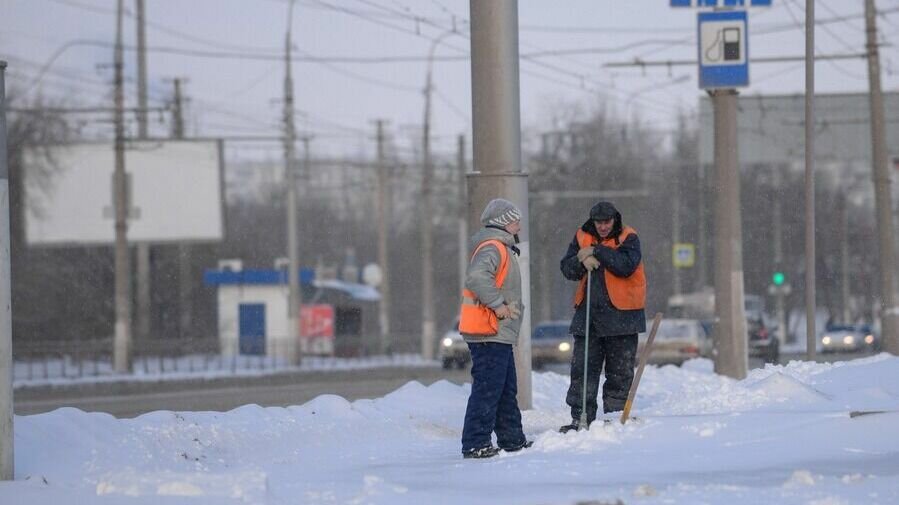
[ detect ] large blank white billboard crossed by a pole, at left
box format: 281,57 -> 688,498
25,140 -> 224,245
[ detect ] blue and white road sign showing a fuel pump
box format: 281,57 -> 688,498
697,11 -> 749,89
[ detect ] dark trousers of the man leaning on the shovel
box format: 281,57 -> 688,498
565,334 -> 637,423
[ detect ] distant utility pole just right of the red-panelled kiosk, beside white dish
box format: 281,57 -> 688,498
375,119 -> 391,354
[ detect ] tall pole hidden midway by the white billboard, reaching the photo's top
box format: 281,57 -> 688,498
135,0 -> 153,340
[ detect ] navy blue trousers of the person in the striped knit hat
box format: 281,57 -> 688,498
462,342 -> 525,452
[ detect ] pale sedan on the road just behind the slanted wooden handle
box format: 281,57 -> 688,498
638,319 -> 714,366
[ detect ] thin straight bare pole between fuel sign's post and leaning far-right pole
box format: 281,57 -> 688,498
805,0 -> 818,361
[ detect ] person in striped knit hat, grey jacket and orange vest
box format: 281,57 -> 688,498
459,198 -> 531,458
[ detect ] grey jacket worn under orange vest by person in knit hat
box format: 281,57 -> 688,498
462,228 -> 524,345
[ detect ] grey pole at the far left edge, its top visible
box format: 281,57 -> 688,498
0,61 -> 15,480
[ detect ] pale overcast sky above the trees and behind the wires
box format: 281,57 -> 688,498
0,0 -> 899,158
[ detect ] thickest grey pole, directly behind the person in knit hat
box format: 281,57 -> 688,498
468,0 -> 532,409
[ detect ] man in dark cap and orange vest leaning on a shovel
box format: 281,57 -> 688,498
559,202 -> 646,433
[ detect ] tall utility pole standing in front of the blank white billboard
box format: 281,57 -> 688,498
113,0 -> 131,373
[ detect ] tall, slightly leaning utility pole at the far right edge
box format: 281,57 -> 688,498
865,0 -> 899,354
